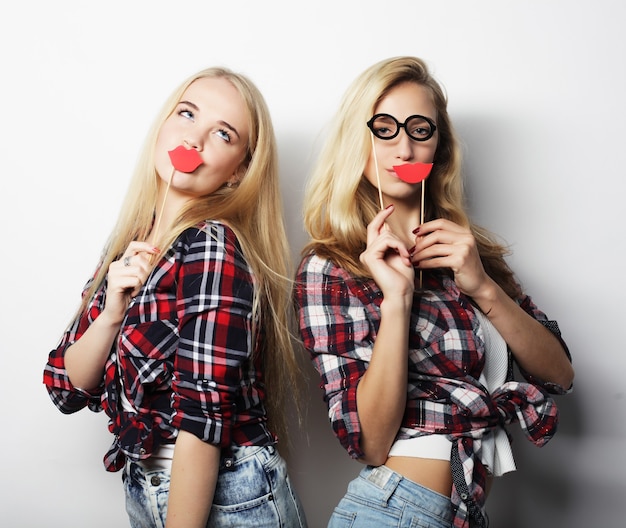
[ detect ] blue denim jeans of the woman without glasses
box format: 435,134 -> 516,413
122,446 -> 307,528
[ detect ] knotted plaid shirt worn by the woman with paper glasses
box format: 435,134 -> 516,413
296,254 -> 569,527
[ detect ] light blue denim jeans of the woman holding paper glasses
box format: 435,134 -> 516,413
328,466 -> 453,528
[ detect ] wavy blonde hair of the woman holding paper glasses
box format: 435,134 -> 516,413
303,57 -> 520,297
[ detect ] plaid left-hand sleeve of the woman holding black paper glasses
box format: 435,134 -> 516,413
295,255 -> 373,458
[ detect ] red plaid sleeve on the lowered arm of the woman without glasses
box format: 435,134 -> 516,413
172,223 -> 255,447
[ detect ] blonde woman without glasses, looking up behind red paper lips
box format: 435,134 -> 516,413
44,68 -> 306,528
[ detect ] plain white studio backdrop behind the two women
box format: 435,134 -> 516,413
0,0 -> 626,528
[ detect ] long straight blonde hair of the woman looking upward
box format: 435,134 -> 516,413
80,68 -> 299,444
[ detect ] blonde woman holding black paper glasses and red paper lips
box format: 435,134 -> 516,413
296,57 -> 574,528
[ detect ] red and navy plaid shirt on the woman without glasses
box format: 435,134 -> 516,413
44,222 -> 276,471
